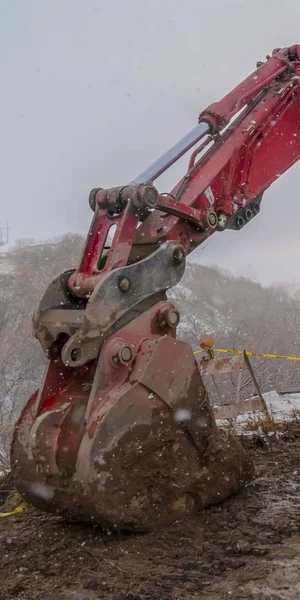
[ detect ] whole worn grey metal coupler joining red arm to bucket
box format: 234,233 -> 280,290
33,242 -> 185,367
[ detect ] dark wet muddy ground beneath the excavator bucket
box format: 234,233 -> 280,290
0,425 -> 300,600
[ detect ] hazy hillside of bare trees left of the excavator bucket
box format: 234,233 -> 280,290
0,235 -> 83,471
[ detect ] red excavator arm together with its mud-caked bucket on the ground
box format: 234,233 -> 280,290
11,45 -> 300,532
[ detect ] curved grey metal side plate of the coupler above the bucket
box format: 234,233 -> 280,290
62,242 -> 185,367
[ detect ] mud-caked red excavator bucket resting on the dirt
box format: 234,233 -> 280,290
11,292 -> 254,531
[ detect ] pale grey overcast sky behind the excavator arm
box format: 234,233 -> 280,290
0,0 -> 300,283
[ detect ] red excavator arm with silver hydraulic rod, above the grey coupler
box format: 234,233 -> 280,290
73,46 -> 300,286
